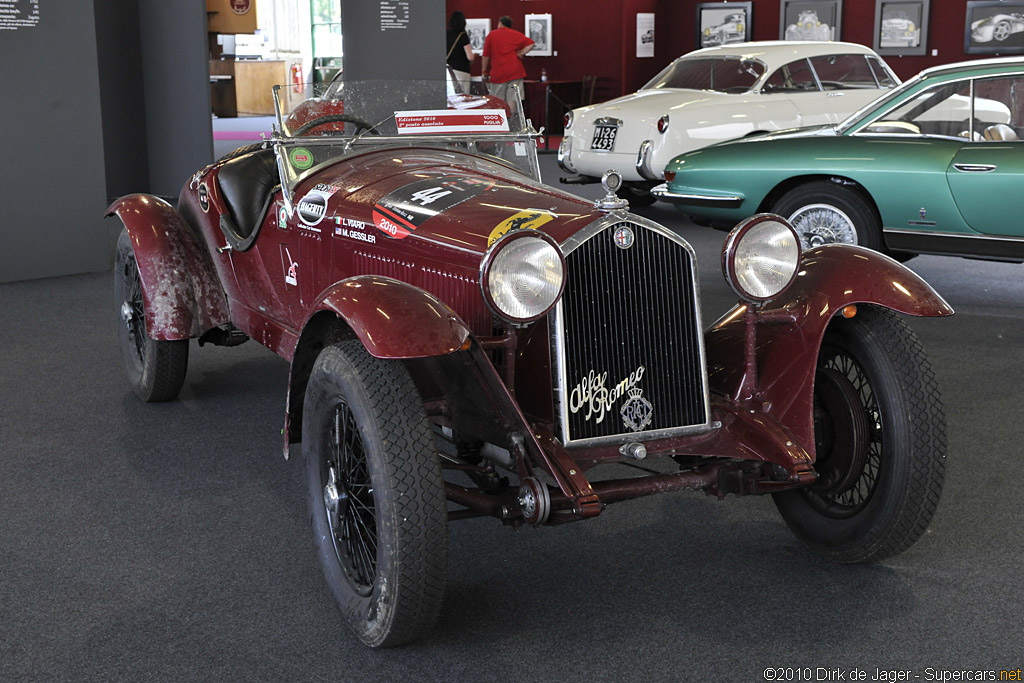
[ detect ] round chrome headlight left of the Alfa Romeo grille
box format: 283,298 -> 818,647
480,228 -> 565,325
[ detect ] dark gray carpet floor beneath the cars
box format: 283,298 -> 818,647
0,157 -> 1024,681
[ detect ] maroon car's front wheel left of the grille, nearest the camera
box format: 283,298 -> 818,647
302,341 -> 447,647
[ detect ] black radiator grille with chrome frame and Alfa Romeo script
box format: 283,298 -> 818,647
555,222 -> 708,443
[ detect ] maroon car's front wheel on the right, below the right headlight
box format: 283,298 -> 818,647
774,305 -> 946,562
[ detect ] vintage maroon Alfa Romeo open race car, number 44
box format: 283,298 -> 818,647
110,78 -> 952,646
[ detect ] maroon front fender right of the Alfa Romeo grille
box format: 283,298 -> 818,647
705,245 -> 953,452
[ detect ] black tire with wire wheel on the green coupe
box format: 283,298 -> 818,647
771,181 -> 884,251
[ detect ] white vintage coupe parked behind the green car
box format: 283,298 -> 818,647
558,41 -> 899,206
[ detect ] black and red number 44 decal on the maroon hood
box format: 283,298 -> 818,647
374,175 -> 495,240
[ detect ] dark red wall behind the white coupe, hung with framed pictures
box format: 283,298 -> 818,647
448,0 -> 988,101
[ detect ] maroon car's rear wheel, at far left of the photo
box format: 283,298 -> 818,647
114,230 -> 188,402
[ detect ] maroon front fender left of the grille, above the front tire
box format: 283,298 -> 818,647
312,275 -> 470,358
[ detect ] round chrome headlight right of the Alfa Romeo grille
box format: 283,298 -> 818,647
722,213 -> 800,303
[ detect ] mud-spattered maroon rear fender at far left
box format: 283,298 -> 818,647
105,195 -> 230,341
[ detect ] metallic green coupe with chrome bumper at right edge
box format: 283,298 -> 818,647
651,58 -> 1024,261
